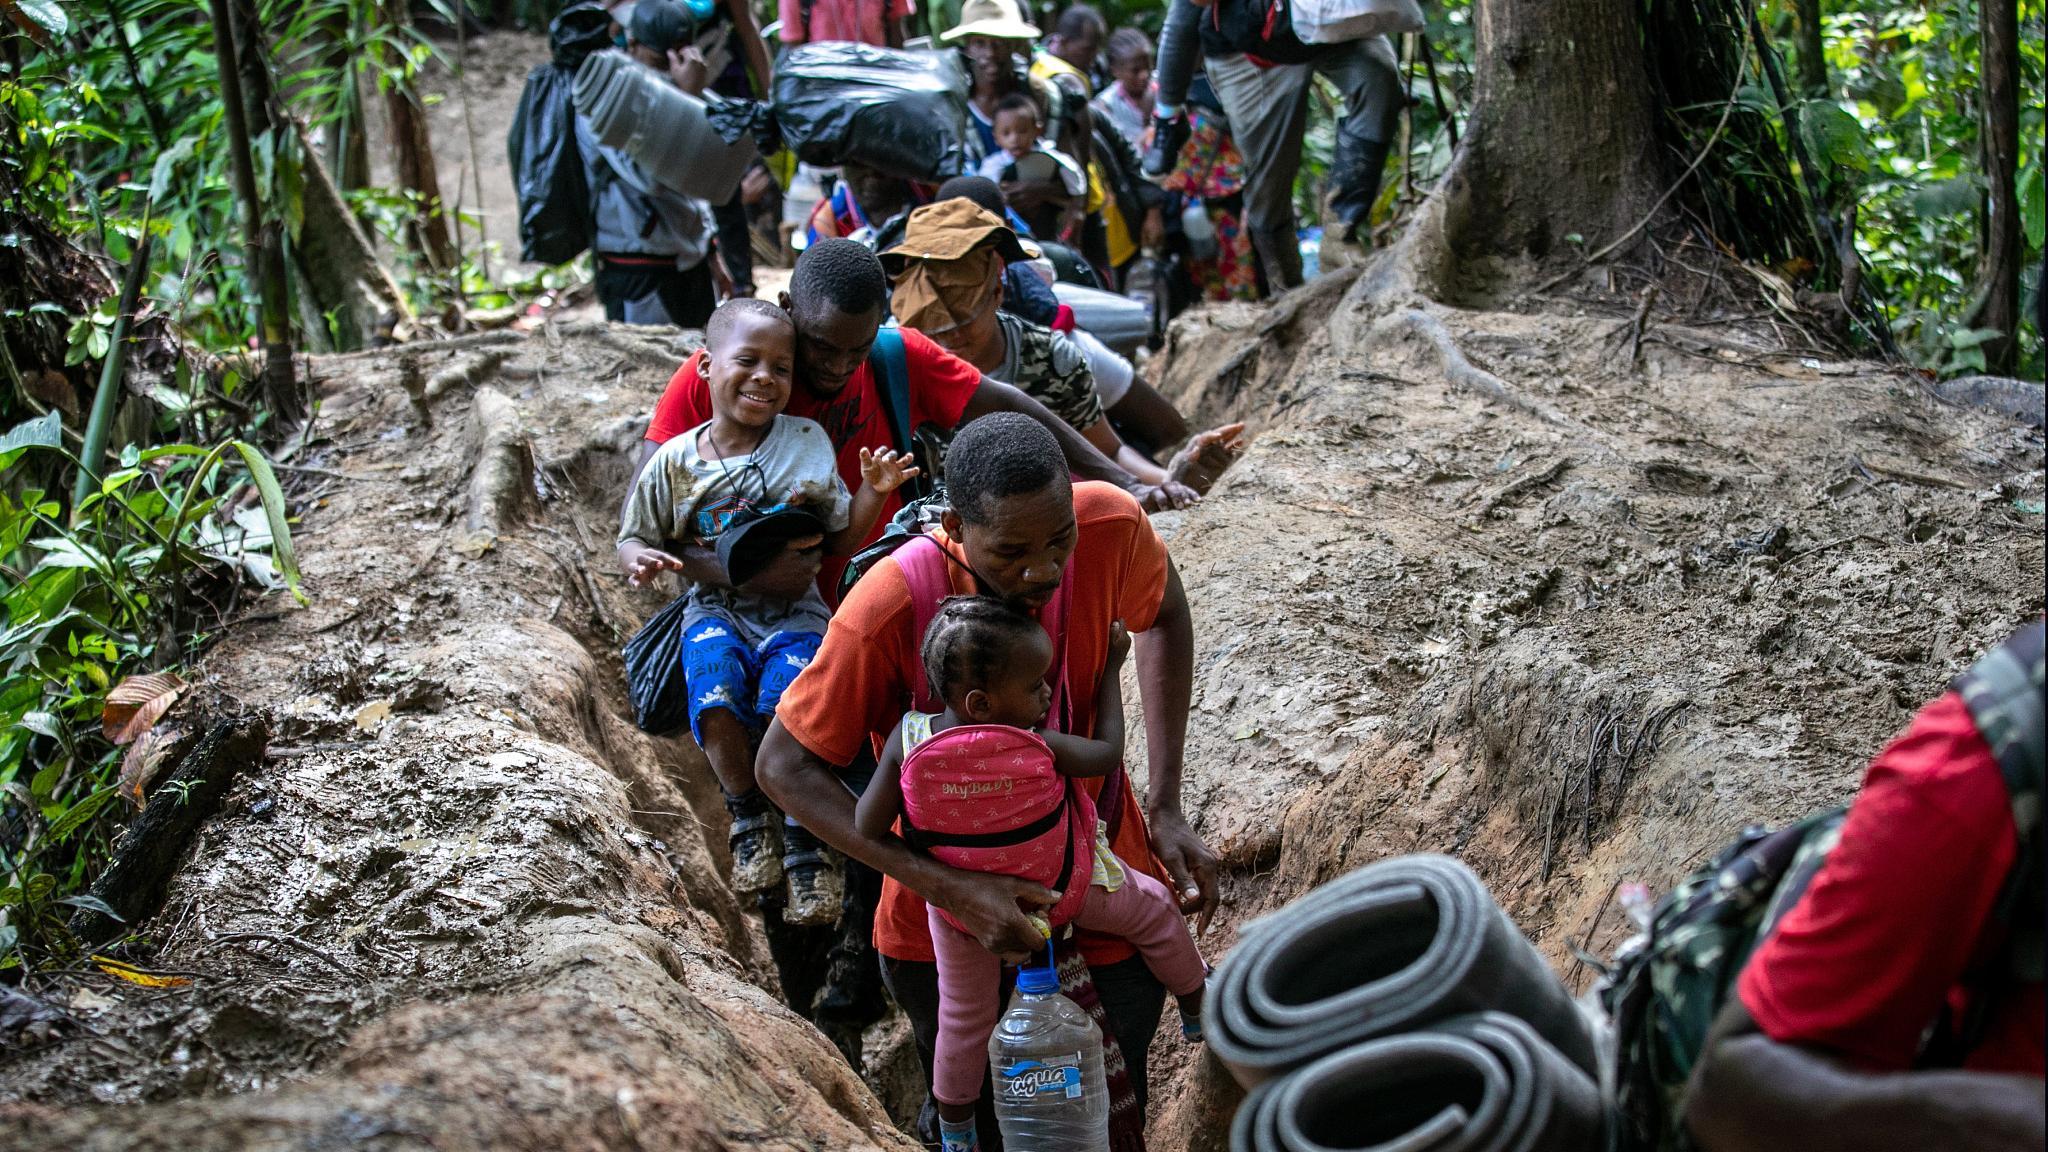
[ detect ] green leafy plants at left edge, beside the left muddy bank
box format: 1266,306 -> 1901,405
0,414 -> 299,968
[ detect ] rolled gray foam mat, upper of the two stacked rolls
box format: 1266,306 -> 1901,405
1202,855 -> 1595,1088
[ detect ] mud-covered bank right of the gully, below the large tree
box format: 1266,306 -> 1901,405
1153,270 -> 2042,1148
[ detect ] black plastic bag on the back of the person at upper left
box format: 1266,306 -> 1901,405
506,4 -> 612,264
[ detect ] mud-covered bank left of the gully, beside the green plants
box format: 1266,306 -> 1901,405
0,326 -> 907,1150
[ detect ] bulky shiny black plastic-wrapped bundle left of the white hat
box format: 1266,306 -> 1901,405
774,41 -> 971,184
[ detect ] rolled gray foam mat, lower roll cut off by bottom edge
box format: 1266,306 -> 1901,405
1231,1013 -> 1604,1152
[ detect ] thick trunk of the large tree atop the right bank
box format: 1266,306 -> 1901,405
1446,0 -> 1661,260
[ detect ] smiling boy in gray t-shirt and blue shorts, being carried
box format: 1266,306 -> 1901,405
618,299 -> 918,924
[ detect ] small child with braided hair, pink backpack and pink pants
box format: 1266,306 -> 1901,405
854,596 -> 1208,1152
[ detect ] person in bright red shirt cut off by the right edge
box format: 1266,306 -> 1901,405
1686,621 -> 2048,1152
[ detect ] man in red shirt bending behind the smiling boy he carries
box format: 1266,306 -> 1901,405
635,240 -> 1198,601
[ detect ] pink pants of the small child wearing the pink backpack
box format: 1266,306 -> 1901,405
930,865 -> 1208,1105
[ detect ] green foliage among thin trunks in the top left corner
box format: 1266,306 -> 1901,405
0,0 -> 479,354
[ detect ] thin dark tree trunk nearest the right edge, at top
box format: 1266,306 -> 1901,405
1974,0 -> 2023,375
